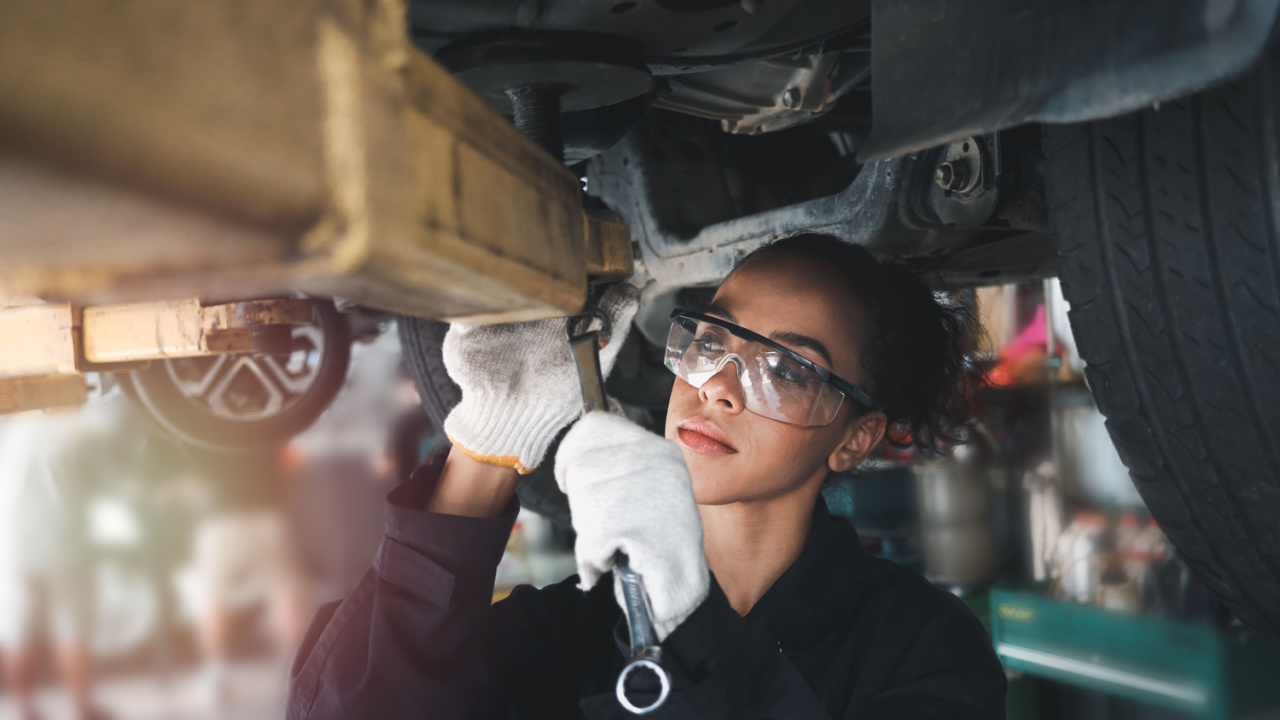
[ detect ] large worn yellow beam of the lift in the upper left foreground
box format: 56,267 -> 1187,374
0,0 -> 609,322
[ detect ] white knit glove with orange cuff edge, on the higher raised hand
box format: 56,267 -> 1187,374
442,283 -> 640,474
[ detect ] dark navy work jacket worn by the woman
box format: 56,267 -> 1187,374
287,465 -> 1005,720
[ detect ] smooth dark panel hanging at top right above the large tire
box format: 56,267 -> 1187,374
859,0 -> 1280,161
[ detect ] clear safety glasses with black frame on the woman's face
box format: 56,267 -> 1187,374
664,309 -> 874,427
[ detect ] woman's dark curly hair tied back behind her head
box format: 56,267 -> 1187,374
739,233 -> 982,456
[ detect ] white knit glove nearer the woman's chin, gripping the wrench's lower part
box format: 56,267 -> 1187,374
556,411 -> 710,641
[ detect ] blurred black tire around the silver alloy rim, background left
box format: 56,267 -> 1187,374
120,300 -> 351,452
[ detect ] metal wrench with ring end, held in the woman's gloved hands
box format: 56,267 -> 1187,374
564,302 -> 671,715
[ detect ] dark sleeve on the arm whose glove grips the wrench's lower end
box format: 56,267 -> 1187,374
582,578 -> 831,720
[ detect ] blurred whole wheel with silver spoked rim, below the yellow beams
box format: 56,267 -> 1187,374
122,300 -> 351,451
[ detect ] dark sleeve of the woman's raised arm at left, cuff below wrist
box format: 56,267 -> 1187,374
285,464 -> 518,720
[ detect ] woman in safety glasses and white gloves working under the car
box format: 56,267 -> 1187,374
288,234 -> 1005,720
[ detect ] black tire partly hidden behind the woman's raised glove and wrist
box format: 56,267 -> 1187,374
396,315 -> 573,528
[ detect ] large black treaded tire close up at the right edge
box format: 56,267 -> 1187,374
1043,51 -> 1280,643
